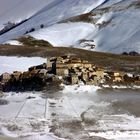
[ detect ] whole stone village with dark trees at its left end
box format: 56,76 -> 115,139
0,56 -> 140,91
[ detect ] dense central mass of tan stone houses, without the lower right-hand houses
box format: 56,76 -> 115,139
47,56 -> 104,85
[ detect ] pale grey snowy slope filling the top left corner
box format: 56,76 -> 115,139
0,0 -> 52,29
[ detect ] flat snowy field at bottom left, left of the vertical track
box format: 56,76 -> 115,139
0,93 -> 65,140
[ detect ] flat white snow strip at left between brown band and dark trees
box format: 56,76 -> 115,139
0,56 -> 46,74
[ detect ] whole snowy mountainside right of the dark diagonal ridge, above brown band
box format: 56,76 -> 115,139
0,0 -> 140,53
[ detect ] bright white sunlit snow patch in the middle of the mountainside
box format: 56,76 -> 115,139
29,22 -> 97,46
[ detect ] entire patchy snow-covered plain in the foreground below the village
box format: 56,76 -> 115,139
0,82 -> 140,140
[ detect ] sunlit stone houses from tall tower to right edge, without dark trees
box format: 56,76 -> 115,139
47,56 -> 140,85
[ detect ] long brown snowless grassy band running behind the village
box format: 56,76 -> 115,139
0,45 -> 140,73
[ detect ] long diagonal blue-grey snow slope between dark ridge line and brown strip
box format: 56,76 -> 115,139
0,0 -> 105,43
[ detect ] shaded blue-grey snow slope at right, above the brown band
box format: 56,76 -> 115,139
94,1 -> 140,53
